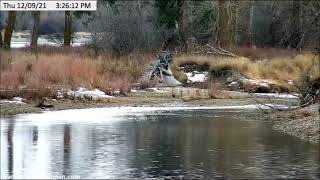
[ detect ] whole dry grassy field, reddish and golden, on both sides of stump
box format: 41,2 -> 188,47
0,47 -> 320,98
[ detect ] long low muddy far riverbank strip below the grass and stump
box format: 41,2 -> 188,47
0,87 -> 297,116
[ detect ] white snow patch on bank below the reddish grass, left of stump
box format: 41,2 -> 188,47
67,87 -> 113,99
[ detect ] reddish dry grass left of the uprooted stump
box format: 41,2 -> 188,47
0,49 -> 152,98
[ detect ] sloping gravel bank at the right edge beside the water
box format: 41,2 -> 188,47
270,104 -> 320,144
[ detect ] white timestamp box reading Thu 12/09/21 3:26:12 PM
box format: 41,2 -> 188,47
0,0 -> 97,11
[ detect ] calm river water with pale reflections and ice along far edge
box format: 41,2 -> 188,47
1,107 -> 320,179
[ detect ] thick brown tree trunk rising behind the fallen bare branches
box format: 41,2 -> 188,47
218,0 -> 235,49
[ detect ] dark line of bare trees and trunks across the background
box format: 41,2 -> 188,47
0,0 -> 320,52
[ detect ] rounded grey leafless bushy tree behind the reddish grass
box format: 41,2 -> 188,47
88,1 -> 162,55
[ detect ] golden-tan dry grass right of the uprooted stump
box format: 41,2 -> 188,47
175,54 -> 320,89
